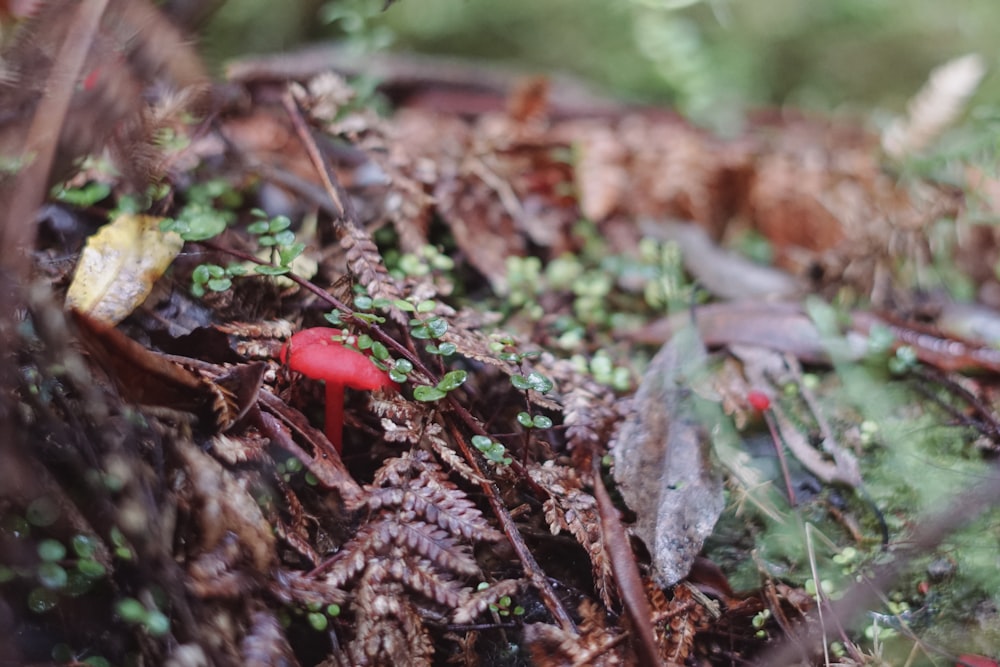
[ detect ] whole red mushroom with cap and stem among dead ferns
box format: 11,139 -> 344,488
280,327 -> 397,452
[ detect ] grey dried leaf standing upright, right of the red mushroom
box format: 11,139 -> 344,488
613,328 -> 724,587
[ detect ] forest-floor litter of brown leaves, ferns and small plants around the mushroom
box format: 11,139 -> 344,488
0,9 -> 1000,665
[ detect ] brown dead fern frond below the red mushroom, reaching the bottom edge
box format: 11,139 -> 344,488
274,452 -> 517,665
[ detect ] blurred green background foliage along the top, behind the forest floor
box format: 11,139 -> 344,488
207,0 -> 1000,125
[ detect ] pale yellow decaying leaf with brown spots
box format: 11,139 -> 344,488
66,214 -> 184,324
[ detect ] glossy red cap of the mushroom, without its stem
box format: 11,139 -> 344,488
280,327 -> 397,389
